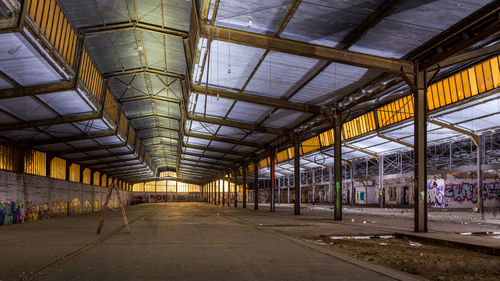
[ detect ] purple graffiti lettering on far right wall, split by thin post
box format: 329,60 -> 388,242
444,182 -> 500,203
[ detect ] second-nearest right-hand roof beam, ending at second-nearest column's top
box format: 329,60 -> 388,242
191,84 -> 323,114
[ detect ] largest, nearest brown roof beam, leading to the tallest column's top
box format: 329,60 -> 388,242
200,23 -> 414,74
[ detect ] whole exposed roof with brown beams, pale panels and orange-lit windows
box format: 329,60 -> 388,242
0,0 -> 500,186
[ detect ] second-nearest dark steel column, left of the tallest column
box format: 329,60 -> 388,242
333,112 -> 342,221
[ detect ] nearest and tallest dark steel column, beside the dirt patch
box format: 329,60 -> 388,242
413,70 -> 427,232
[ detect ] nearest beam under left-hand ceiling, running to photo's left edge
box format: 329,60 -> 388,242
0,81 -> 76,99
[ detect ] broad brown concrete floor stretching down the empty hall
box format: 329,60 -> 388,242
0,203 -> 426,280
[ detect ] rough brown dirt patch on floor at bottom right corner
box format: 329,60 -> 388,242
312,236 -> 500,281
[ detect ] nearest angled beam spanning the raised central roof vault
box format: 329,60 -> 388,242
78,21 -> 188,39
